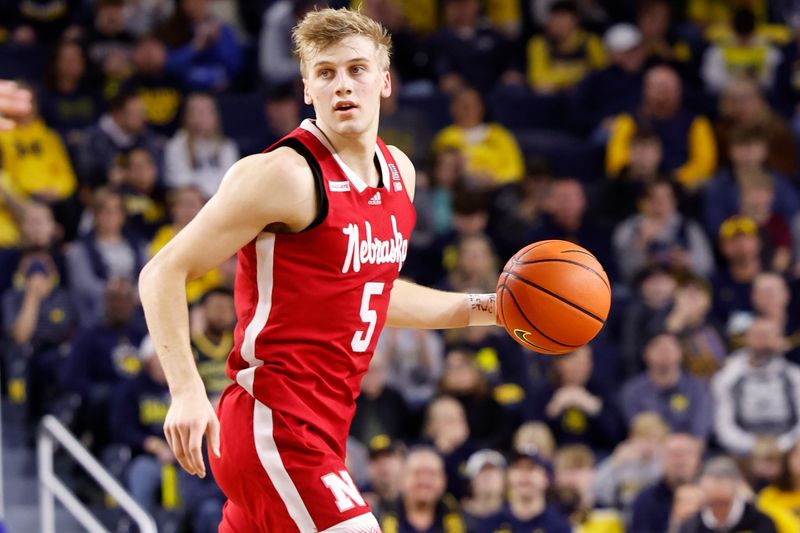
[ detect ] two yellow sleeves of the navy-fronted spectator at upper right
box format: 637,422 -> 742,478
606,113 -> 717,189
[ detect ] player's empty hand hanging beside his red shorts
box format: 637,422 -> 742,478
164,387 -> 220,478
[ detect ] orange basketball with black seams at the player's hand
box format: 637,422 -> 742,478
497,240 -> 611,355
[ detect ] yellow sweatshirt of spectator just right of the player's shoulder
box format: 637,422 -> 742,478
433,123 -> 525,185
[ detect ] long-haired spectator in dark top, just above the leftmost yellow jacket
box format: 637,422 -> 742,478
41,40 -> 103,152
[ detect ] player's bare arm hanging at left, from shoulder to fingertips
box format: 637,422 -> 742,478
139,148 -> 317,477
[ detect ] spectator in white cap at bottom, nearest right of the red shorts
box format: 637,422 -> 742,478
461,449 -> 506,531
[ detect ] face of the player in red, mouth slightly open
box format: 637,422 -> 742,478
303,36 -> 391,136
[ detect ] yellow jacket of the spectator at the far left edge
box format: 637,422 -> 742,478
0,120 -> 78,200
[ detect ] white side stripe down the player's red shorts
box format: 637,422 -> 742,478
253,400 -> 316,533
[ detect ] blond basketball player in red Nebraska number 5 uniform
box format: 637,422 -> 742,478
140,9 -> 496,533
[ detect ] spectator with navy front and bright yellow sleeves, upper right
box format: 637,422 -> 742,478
606,65 -> 717,191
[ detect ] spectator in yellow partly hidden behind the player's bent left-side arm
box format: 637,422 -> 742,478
147,186 -> 223,303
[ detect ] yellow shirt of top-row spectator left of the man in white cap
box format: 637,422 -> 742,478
528,31 -> 606,90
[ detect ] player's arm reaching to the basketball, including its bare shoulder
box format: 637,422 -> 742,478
386,146 -> 497,329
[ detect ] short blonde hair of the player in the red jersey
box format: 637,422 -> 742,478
292,8 -> 392,76
